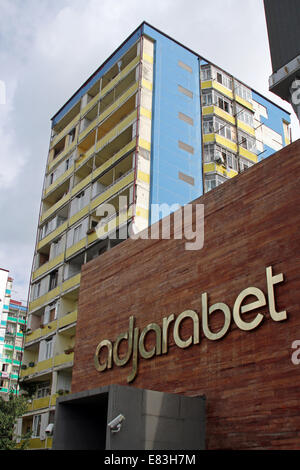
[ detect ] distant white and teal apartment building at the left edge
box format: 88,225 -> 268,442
0,268 -> 27,399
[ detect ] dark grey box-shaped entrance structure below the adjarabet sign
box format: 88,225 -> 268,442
53,385 -> 205,450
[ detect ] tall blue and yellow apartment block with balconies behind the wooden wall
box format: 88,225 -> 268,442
19,22 -> 290,448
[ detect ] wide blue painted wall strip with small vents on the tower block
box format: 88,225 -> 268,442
144,25 -> 203,224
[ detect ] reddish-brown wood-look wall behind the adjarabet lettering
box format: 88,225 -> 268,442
72,141 -> 300,449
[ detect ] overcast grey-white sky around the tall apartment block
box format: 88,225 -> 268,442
0,0 -> 299,300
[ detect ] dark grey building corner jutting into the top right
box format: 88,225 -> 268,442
264,0 -> 300,119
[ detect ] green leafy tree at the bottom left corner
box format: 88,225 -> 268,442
0,393 -> 29,450
